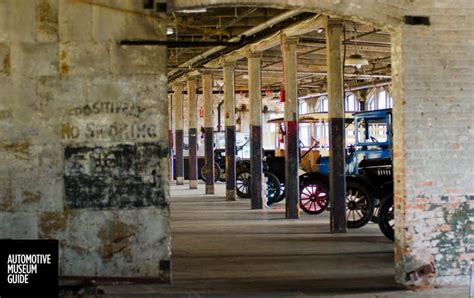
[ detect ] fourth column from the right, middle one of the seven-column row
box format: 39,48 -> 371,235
224,61 -> 236,201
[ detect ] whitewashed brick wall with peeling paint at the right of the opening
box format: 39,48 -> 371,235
392,1 -> 474,286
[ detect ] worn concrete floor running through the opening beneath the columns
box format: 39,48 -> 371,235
101,184 -> 468,297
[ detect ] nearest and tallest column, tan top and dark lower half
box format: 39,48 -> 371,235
326,19 -> 347,233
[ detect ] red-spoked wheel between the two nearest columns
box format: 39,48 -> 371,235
300,180 -> 329,214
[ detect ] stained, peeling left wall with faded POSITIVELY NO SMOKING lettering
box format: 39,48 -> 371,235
0,0 -> 170,282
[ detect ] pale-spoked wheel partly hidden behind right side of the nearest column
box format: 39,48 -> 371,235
346,182 -> 374,229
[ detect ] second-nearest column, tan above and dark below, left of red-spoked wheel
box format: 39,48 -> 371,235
283,37 -> 300,218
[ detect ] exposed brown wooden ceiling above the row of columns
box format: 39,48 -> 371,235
168,7 -> 391,95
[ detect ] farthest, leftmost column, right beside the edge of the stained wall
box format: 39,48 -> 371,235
173,82 -> 184,185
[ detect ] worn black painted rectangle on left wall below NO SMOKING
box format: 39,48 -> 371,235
64,143 -> 168,208
